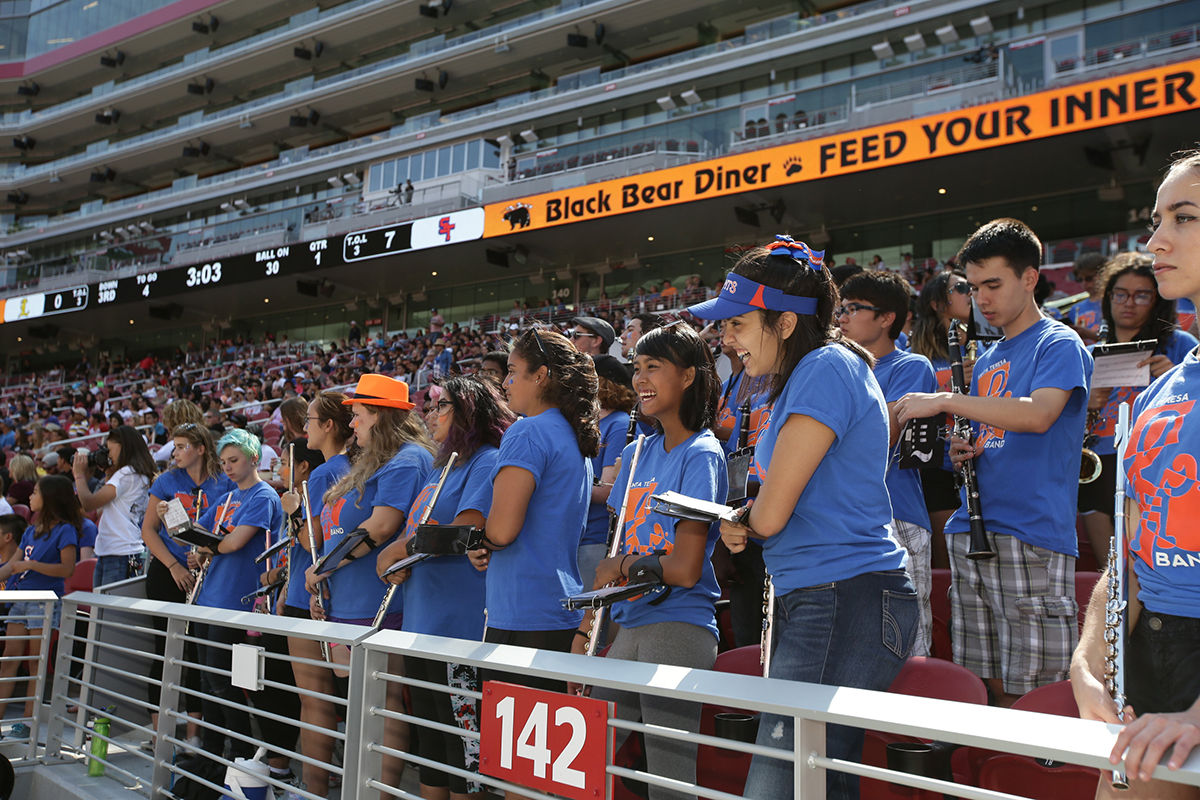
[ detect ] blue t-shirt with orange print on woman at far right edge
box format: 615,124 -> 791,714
1122,353 -> 1200,616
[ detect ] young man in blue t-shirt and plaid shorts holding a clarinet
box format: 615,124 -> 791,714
895,219 -> 1092,706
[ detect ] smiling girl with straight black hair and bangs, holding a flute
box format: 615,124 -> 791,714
572,324 -> 728,800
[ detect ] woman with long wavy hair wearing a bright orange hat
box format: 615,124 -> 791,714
305,373 -> 433,786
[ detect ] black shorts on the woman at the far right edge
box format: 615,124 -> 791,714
1124,608 -> 1200,716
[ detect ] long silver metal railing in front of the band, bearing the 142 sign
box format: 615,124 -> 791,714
25,582 -> 1200,800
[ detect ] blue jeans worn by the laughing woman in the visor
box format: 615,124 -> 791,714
745,570 -> 920,800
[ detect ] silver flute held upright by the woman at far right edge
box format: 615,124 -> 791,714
1104,403 -> 1129,789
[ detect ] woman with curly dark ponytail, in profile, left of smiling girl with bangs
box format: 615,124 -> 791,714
472,330 -> 600,691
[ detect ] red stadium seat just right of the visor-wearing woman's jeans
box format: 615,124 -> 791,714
860,656 -> 988,800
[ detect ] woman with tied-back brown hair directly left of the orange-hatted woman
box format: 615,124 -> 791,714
282,392 -> 354,798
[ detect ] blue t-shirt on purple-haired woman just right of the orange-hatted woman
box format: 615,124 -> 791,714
403,445 -> 500,642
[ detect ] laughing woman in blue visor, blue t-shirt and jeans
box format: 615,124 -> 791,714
690,236 -> 918,800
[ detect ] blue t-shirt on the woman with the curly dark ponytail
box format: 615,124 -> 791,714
487,408 -> 592,631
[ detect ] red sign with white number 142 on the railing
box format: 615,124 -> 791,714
479,681 -> 613,800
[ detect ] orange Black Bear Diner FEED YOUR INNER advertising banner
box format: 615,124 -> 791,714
484,59 -> 1200,239
